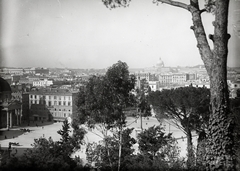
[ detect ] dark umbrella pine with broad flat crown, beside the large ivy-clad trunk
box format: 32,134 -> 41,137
149,86 -> 210,167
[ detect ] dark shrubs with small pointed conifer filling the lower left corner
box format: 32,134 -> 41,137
0,120 -> 86,171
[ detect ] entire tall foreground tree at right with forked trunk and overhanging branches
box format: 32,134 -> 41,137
102,0 -> 236,170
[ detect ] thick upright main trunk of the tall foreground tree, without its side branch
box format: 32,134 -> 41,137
206,0 -> 235,170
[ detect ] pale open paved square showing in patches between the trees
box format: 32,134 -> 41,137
0,117 -> 196,160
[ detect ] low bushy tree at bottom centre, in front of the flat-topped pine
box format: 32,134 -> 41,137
125,126 -> 183,171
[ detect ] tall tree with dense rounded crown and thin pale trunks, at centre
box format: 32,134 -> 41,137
77,61 -> 135,169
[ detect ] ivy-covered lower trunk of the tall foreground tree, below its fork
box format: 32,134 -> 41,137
206,60 -> 234,170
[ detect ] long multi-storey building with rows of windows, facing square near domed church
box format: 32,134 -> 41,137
29,88 -> 77,121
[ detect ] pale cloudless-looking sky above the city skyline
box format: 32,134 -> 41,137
0,0 -> 240,69
